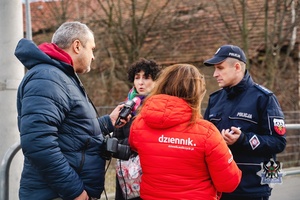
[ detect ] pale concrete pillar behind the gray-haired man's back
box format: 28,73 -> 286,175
0,0 -> 24,200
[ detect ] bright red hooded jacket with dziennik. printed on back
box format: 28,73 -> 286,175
129,95 -> 241,200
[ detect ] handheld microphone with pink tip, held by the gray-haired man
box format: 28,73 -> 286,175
116,97 -> 141,126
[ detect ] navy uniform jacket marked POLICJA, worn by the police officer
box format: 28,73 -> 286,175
204,71 -> 286,198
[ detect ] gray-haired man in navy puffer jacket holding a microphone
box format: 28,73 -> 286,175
15,22 -> 126,200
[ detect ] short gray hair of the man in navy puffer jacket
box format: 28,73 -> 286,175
51,21 -> 93,49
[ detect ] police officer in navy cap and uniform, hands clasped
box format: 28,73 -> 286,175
204,45 -> 286,200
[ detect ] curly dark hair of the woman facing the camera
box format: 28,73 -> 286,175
127,58 -> 160,83
